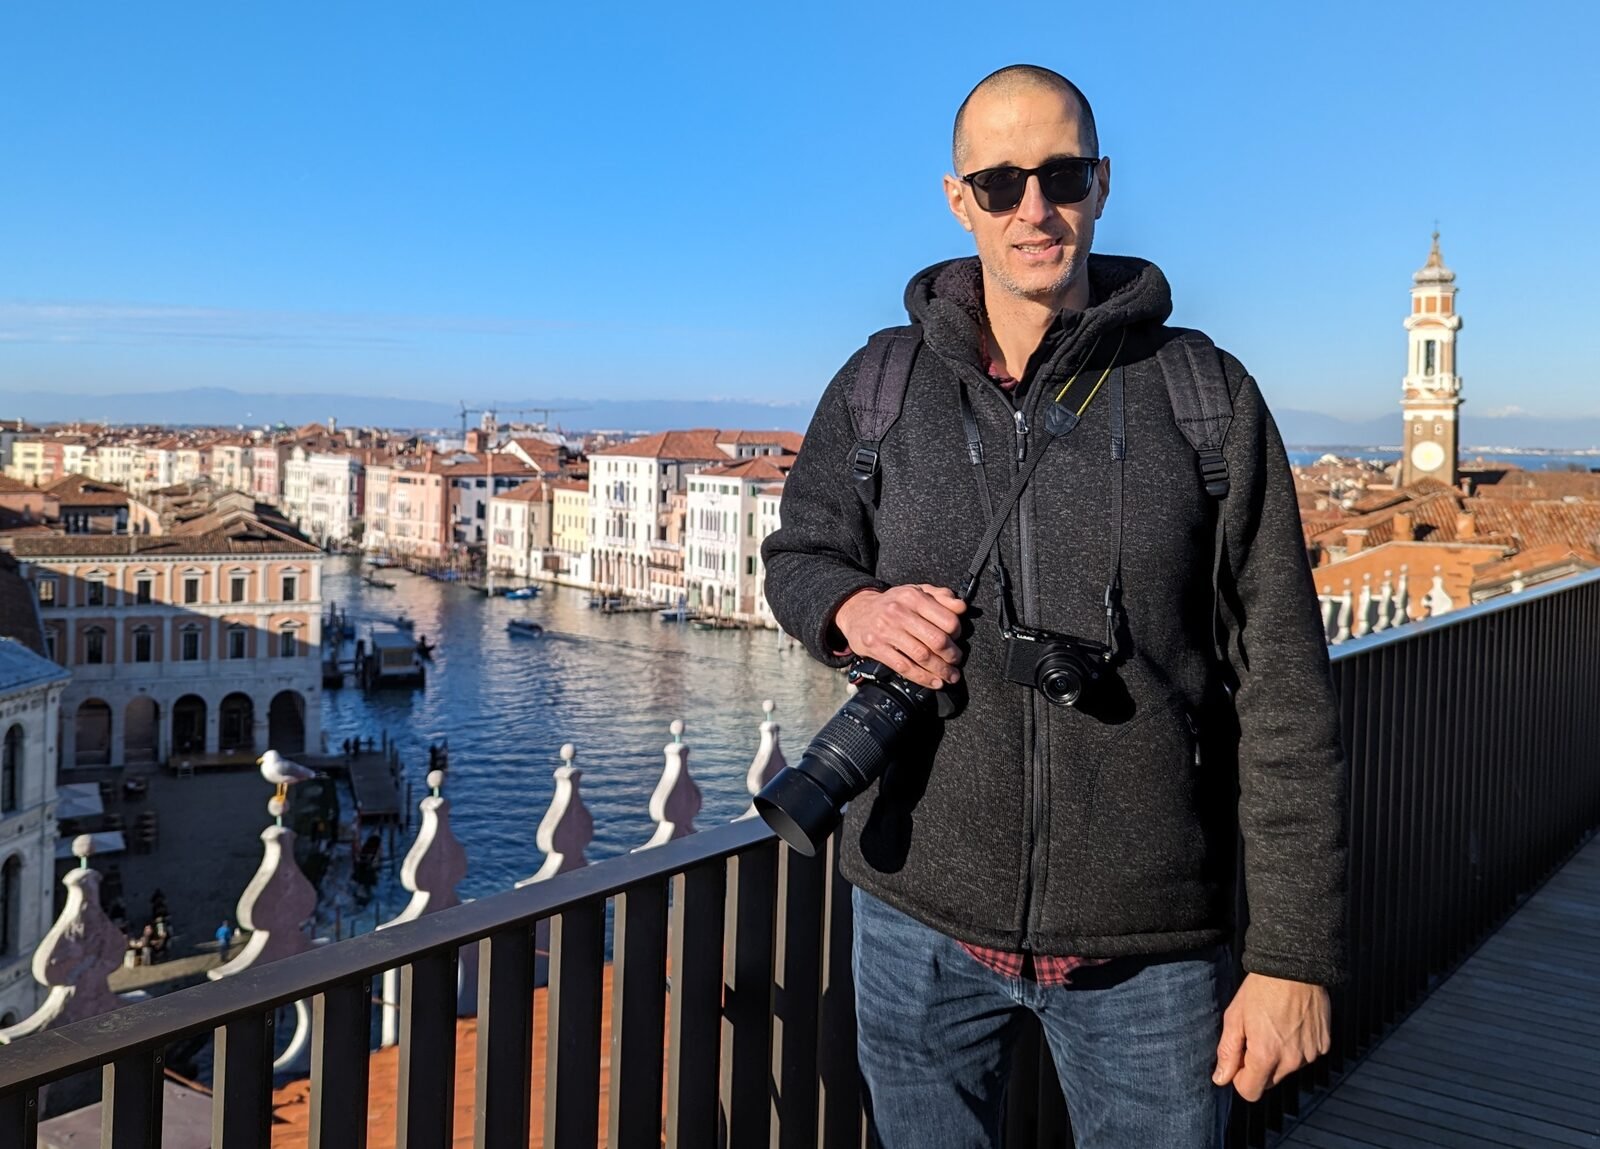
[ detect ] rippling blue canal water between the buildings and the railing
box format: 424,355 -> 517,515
322,557 -> 845,917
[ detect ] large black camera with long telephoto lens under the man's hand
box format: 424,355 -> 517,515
755,659 -> 939,858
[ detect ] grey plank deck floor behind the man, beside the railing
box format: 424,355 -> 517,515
1278,839 -> 1600,1149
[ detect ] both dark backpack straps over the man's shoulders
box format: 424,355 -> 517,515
848,323 -> 1234,663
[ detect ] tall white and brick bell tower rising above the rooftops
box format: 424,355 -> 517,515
1400,232 -> 1461,486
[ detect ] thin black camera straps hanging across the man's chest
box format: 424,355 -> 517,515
958,333 -> 1126,658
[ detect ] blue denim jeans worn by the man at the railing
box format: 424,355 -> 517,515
853,890 -> 1230,1149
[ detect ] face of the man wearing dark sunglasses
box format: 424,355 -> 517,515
944,88 -> 1110,307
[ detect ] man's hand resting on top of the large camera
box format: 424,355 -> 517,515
834,583 -> 966,690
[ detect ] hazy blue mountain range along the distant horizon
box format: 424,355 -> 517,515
9,387 -> 1600,450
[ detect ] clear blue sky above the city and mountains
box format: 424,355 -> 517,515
0,2 -> 1600,418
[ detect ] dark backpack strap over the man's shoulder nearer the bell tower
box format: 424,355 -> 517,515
1155,331 -> 1234,664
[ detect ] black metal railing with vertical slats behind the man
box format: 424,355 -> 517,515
0,571 -> 1600,1149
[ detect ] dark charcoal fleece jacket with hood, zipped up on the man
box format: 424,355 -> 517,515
763,256 -> 1346,984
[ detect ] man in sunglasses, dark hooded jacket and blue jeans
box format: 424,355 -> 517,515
765,67 -> 1344,1149
